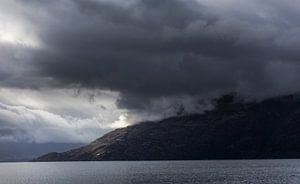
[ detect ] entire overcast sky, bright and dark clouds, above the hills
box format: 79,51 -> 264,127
0,0 -> 300,143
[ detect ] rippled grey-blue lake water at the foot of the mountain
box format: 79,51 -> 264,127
0,160 -> 300,184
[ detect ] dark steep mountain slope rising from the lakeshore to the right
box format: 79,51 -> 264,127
35,95 -> 300,161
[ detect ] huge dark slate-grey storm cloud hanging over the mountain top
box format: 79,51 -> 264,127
8,0 -> 300,108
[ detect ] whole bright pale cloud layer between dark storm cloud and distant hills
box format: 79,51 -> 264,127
0,89 -> 127,143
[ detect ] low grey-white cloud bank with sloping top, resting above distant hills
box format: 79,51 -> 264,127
0,103 -> 110,143
